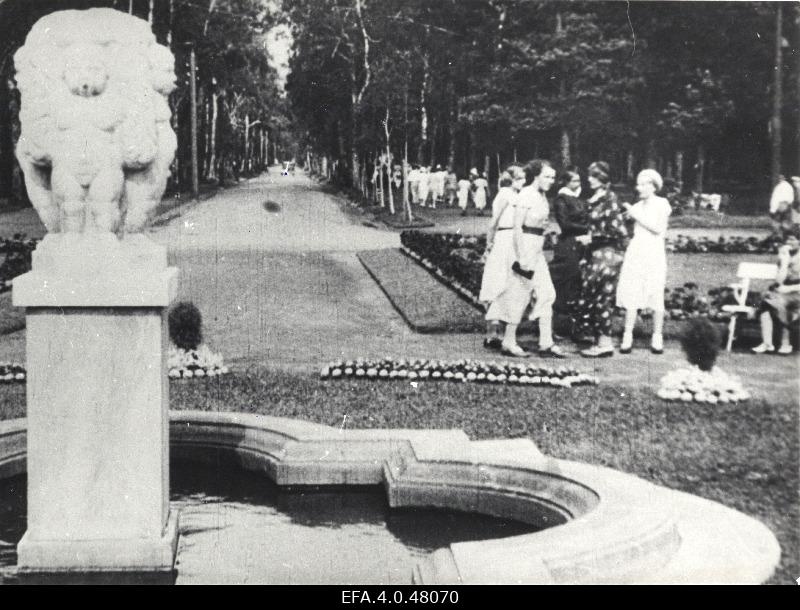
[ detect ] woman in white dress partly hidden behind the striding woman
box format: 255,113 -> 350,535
478,165 -> 525,349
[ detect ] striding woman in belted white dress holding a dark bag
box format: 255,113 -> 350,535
486,159 -> 564,358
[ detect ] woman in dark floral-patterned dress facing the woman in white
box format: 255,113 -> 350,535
576,161 -> 629,358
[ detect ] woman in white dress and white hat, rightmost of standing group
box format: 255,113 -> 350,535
617,169 -> 672,354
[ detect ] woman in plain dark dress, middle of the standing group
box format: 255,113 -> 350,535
550,167 -> 589,330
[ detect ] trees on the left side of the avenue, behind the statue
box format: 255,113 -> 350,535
0,0 -> 293,201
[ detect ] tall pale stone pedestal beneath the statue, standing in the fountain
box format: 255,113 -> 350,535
13,233 -> 178,572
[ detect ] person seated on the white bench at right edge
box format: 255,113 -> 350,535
753,228 -> 800,354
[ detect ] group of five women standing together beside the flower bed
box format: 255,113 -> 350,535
479,159 -> 672,358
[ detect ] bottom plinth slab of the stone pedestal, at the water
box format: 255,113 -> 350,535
17,511 -> 178,576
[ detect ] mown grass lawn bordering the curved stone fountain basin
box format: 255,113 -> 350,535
0,369 -> 800,584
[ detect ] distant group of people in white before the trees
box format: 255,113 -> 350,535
408,165 -> 489,214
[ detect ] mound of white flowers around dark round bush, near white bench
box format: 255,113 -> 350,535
657,366 -> 750,404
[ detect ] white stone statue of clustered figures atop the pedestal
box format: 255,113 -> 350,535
14,8 -> 177,235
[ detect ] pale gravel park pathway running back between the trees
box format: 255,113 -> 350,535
0,170 -> 798,400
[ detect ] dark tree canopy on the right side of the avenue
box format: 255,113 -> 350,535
283,0 -> 800,204
